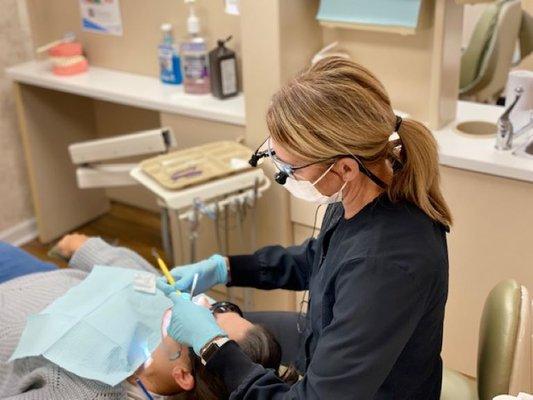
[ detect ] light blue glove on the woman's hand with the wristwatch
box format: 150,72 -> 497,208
167,292 -> 228,355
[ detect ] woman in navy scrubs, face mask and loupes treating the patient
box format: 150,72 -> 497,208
158,57 -> 451,400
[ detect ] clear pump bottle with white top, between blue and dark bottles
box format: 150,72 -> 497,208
181,0 -> 211,94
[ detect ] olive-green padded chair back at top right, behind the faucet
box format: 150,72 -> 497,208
459,0 -> 523,103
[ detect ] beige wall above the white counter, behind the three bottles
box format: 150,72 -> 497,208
27,0 -> 241,81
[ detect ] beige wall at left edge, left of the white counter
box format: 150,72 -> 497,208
0,0 -> 33,231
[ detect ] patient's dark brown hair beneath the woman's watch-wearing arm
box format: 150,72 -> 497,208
187,325 -> 281,400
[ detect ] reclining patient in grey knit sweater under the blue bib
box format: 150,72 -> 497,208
0,234 -> 281,400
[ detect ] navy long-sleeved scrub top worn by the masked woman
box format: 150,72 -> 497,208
207,194 -> 448,400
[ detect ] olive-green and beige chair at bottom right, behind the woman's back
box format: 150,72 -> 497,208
441,279 -> 533,400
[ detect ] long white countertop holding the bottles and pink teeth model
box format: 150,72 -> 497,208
6,61 -> 245,126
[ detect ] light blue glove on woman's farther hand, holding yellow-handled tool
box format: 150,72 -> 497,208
157,254 -> 228,295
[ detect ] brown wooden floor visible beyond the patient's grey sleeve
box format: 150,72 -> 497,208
21,203 -> 163,267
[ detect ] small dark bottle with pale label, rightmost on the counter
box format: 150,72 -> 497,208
209,36 -> 239,99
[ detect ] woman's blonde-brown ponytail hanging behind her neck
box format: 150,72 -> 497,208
388,119 -> 452,226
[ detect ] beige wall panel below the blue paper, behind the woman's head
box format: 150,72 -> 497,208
322,0 -> 462,128
